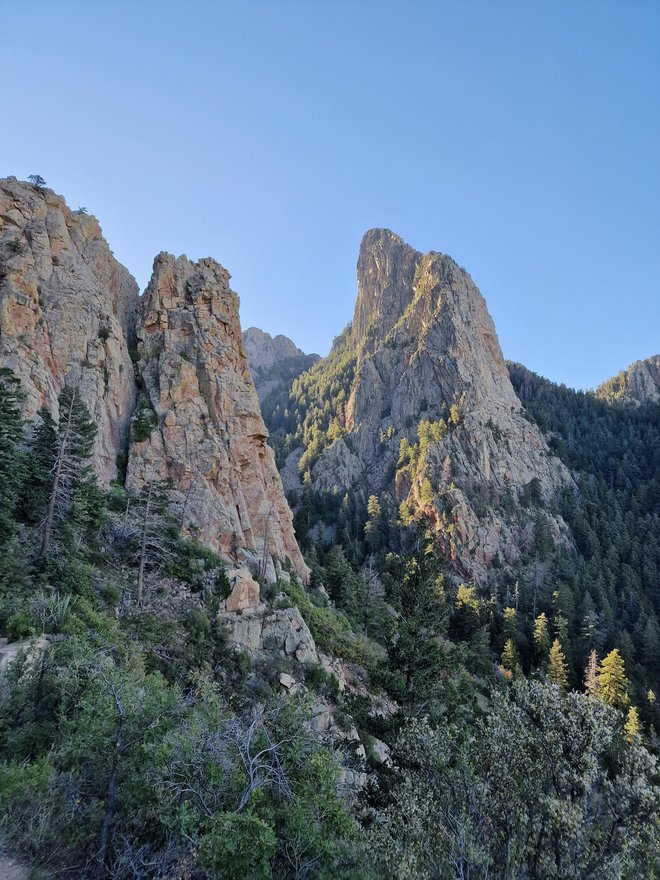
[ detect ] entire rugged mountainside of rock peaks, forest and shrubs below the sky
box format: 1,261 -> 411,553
0,178 -> 660,880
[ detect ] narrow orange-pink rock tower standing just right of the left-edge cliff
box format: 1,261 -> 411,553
127,253 -> 307,579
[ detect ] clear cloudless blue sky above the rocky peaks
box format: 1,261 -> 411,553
0,0 -> 660,387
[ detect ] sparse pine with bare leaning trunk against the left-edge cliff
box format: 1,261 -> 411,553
41,388 -> 96,556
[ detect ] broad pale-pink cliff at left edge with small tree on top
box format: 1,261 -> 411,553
0,177 -> 138,484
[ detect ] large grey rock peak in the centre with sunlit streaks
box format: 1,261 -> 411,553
313,230 -> 570,576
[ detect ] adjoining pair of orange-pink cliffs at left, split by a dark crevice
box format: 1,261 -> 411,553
0,178 -> 307,578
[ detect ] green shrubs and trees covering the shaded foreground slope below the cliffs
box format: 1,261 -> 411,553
0,355 -> 659,880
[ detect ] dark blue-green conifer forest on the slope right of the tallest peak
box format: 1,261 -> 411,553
510,365 -> 660,724
